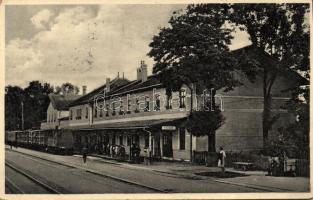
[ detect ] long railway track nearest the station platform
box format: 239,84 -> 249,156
6,150 -> 168,194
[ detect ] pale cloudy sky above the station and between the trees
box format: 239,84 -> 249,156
5,5 -> 250,91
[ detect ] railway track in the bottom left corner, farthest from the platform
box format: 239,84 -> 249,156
5,161 -> 62,194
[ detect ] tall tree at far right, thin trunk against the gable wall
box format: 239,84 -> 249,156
228,4 -> 310,147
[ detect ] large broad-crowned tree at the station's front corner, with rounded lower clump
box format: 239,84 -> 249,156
148,4 -> 253,159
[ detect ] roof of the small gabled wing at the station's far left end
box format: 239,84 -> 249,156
49,94 -> 80,111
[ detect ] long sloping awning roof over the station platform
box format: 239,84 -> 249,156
71,118 -> 186,130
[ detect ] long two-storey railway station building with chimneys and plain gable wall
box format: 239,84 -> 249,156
39,47 -> 301,161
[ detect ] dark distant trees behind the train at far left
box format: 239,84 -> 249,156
5,81 -> 79,130
